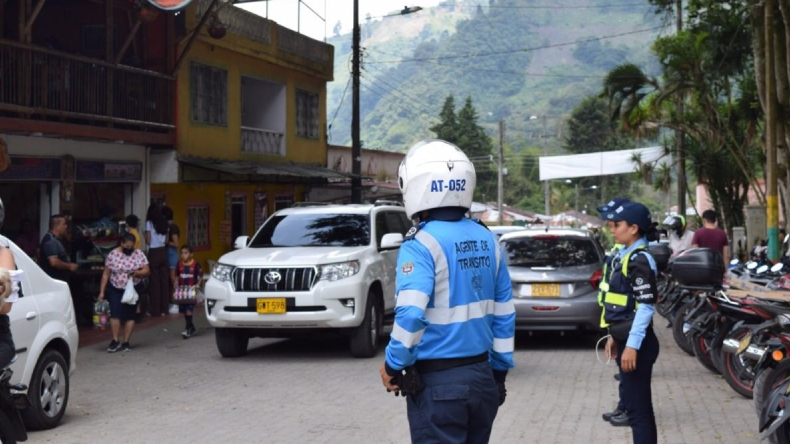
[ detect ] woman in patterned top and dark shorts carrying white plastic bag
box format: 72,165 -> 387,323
99,233 -> 149,353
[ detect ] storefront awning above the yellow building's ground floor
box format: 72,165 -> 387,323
178,156 -> 352,184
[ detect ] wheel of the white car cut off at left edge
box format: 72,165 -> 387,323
21,349 -> 69,430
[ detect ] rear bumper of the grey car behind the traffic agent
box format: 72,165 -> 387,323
513,291 -> 601,330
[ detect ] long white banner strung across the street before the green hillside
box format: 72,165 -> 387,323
539,146 -> 670,181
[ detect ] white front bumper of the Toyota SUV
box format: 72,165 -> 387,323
205,273 -> 368,329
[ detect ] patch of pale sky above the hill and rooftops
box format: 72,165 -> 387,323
237,0 -> 442,41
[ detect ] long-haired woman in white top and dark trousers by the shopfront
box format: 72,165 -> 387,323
145,203 -> 172,316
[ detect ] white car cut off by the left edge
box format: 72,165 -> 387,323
0,236 -> 79,430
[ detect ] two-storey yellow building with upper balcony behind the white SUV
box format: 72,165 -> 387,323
151,0 -> 345,264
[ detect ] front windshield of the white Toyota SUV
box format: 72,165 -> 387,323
249,214 -> 370,248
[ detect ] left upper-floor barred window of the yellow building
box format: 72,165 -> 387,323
190,62 -> 228,126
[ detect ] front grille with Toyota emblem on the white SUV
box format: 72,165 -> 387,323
233,267 -> 317,292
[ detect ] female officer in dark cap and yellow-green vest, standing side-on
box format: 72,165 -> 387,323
603,202 -> 658,444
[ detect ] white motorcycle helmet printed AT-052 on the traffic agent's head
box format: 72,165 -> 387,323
398,139 -> 477,218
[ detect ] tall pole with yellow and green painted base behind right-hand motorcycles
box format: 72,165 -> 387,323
765,0 -> 784,261
